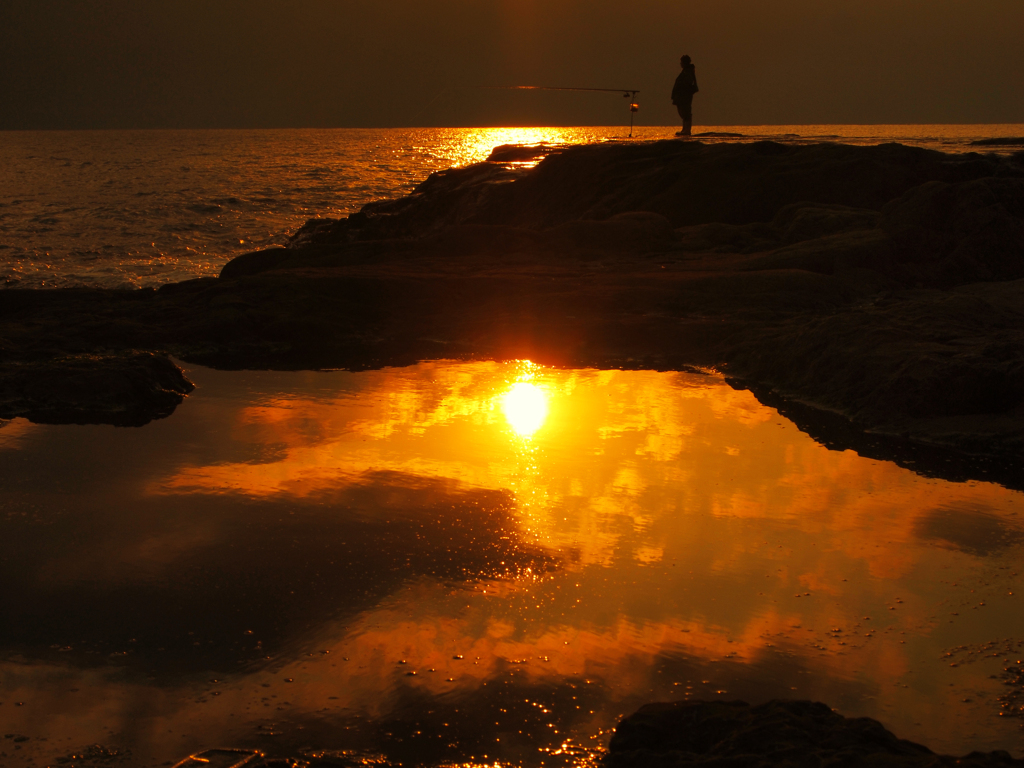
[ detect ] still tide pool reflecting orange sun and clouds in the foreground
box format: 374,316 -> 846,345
0,362 -> 1024,766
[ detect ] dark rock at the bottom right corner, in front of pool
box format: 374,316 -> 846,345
604,700 -> 1024,768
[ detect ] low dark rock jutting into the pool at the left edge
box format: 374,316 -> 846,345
0,352 -> 195,426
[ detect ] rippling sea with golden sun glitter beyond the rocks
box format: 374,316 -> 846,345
0,125 -> 1024,289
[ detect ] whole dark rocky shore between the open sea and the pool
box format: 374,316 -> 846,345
0,141 -> 1024,465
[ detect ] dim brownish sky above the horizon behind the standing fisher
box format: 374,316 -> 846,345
0,0 -> 1024,129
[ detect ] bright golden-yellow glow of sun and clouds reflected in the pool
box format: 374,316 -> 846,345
147,361 -> 1013,589
